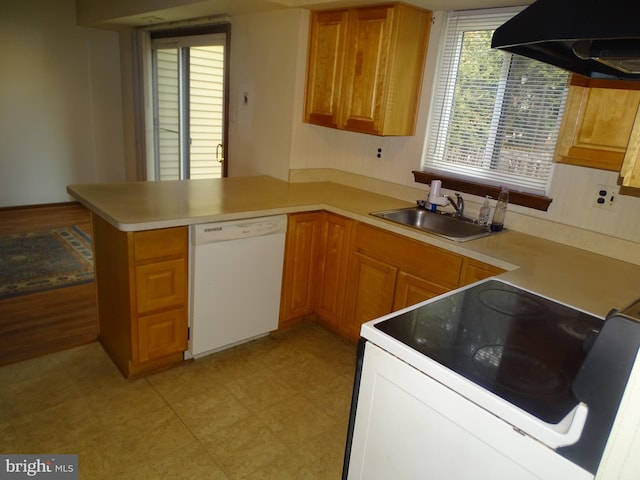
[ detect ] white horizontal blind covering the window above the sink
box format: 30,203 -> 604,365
423,9 -> 568,195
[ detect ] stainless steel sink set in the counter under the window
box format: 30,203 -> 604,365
371,207 -> 493,242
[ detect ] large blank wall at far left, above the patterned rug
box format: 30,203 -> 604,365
0,0 -> 124,207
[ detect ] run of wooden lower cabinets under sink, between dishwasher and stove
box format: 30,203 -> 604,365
280,212 -> 503,343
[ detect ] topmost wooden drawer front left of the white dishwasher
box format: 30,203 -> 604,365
134,227 -> 187,263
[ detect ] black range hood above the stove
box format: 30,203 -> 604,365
491,0 -> 640,81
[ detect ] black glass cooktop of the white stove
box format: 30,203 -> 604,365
375,280 -> 602,423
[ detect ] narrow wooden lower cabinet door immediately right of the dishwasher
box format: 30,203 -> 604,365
279,212 -> 324,327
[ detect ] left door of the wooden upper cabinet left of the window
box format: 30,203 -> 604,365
305,10 -> 348,128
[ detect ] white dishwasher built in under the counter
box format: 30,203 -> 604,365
188,215 -> 287,358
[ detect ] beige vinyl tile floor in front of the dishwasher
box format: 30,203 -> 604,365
0,323 -> 355,480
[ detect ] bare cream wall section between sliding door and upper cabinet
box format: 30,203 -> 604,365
228,10 -> 306,180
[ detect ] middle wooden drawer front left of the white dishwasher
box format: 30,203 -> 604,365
136,259 -> 187,314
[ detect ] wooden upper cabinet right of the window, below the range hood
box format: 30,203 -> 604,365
555,76 -> 640,172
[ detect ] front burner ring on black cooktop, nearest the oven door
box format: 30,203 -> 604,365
473,345 -> 569,397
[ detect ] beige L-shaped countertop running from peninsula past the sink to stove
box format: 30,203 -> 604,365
67,176 -> 640,316
